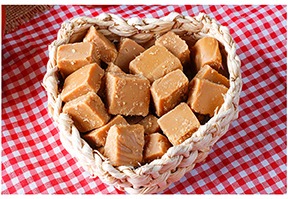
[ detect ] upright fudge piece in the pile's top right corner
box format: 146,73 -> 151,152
192,37 -> 222,71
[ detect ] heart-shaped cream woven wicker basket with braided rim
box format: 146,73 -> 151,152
43,13 -> 242,193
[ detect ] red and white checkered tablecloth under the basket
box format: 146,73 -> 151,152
1,5 -> 287,194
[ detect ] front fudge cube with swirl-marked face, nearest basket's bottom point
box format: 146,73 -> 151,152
104,124 -> 145,166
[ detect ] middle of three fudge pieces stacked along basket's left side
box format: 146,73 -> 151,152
61,63 -> 104,102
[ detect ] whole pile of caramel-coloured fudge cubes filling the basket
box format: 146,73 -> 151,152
57,26 -> 229,167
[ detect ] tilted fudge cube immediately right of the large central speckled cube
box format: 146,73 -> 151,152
150,69 -> 189,117
